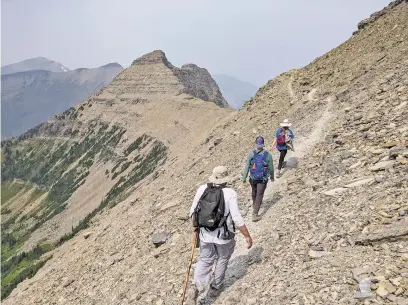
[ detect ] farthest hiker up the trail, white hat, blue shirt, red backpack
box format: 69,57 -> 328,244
272,119 -> 295,178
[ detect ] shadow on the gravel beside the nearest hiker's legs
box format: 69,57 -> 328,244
198,247 -> 263,305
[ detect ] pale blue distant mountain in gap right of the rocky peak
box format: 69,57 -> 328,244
212,74 -> 258,110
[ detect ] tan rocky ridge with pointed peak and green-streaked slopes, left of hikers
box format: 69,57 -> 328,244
2,50 -> 232,298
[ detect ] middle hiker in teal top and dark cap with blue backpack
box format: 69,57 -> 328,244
242,136 -> 275,222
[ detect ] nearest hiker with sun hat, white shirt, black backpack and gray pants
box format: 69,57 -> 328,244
188,166 -> 252,304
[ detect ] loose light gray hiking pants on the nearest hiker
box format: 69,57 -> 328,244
194,239 -> 235,292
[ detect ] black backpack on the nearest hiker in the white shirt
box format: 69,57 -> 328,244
193,183 -> 228,231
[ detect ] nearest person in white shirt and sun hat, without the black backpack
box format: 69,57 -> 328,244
188,166 -> 252,304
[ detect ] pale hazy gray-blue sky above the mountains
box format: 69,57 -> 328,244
1,0 -> 389,86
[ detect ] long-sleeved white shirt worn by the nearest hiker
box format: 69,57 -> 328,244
190,184 -> 245,244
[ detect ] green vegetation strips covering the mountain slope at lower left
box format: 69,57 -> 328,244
1,127 -> 167,299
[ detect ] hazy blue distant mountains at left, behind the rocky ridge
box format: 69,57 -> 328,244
1,57 -> 123,138
